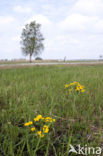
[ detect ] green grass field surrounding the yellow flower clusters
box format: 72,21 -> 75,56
0,65 -> 103,156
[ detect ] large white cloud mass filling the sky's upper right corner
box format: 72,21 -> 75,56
59,0 -> 103,33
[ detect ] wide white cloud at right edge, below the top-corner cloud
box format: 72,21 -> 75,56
59,14 -> 103,33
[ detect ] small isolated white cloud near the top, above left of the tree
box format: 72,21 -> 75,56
13,5 -> 32,13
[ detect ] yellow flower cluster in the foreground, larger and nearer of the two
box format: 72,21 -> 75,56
24,115 -> 55,138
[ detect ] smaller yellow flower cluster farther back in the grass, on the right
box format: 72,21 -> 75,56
65,82 -> 85,93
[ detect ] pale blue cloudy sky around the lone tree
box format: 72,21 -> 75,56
0,0 -> 103,60
